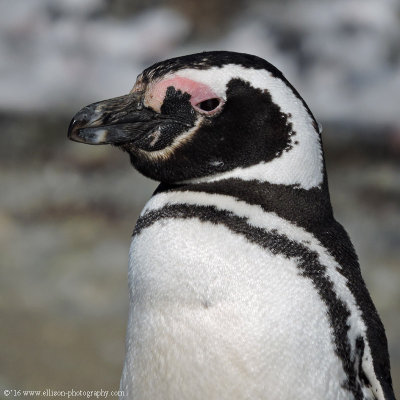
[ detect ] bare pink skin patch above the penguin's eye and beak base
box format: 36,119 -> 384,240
145,76 -> 218,112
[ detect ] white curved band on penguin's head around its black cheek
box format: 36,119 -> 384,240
174,64 -> 323,189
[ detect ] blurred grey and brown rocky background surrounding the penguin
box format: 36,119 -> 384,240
0,0 -> 400,397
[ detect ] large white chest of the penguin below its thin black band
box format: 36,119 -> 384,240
121,219 -> 349,400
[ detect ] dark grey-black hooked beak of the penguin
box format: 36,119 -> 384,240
68,91 -> 159,145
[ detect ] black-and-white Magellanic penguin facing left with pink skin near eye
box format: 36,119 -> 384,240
69,51 -> 394,400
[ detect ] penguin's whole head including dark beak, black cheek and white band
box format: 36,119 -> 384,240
68,51 -> 323,189
